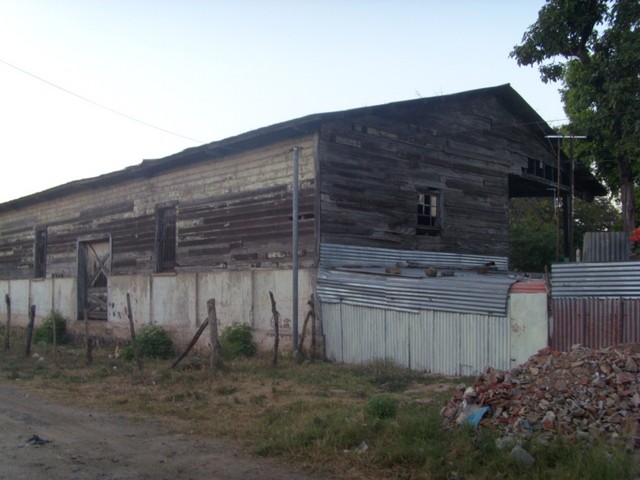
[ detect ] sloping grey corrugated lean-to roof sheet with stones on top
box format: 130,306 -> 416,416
317,268 -> 517,315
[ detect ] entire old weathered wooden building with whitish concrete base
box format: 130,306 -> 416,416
0,85 -> 604,346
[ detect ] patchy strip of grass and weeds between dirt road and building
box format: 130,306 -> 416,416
0,334 -> 636,480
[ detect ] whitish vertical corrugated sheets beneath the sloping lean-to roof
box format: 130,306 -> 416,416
322,302 -> 512,375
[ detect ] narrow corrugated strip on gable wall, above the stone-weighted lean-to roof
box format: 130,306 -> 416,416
320,243 -> 508,271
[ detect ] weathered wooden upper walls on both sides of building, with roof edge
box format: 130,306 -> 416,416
0,86 -> 593,279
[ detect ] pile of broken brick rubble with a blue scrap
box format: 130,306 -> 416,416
442,344 -> 640,447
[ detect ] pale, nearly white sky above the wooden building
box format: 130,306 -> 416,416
0,0 -> 565,202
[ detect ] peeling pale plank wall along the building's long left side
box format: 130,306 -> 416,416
0,136 -> 316,279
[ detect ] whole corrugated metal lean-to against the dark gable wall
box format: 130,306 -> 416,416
317,244 -> 517,375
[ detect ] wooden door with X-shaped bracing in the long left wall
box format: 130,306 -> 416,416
78,239 -> 111,320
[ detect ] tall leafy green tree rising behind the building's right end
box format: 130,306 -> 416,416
511,0 -> 640,235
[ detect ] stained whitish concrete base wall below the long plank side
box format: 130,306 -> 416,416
0,269 -> 320,351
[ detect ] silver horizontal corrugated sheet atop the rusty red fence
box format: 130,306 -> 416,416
551,262 -> 640,298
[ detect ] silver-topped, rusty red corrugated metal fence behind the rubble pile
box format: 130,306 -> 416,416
549,262 -> 640,351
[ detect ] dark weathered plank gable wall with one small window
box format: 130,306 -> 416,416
318,94 -> 553,256
